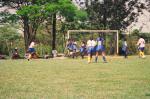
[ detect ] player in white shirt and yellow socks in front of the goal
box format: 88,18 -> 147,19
87,37 -> 96,63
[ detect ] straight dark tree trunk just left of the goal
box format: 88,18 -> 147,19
52,13 -> 56,50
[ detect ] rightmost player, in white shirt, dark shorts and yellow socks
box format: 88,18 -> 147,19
137,36 -> 145,58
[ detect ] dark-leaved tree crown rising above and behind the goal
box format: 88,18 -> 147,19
87,0 -> 144,29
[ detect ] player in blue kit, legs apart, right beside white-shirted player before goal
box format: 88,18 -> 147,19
95,35 -> 107,63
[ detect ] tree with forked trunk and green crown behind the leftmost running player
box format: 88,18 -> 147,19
17,4 -> 43,49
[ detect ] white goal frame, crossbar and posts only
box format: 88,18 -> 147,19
67,30 -> 119,54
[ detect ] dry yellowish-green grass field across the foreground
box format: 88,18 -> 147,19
0,56 -> 150,99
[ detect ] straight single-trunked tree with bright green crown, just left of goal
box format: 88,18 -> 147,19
41,0 -> 86,50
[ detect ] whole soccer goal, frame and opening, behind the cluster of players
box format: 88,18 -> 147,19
67,30 -> 119,55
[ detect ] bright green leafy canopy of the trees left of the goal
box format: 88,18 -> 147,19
17,0 -> 87,21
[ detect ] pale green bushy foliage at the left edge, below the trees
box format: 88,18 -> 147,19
0,24 -> 22,55
